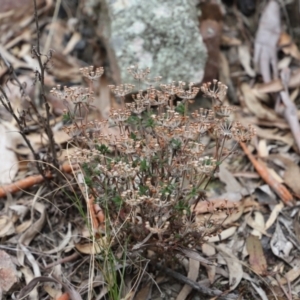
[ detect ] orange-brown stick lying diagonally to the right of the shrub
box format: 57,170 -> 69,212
240,142 -> 293,205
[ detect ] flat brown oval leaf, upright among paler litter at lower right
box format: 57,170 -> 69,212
246,234 -> 267,275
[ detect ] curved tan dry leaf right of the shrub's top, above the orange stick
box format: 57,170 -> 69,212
240,83 -> 278,121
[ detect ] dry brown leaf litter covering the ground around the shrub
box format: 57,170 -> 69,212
0,1 -> 300,299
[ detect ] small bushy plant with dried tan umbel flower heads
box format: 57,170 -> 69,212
52,66 -> 255,264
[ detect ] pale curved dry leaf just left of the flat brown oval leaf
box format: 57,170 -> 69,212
215,244 -> 243,291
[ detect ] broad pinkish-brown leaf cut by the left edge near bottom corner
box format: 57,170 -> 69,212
0,250 -> 18,297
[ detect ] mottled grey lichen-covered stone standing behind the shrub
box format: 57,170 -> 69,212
101,0 -> 206,84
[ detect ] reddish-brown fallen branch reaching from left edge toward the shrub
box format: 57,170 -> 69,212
0,165 -> 76,198
